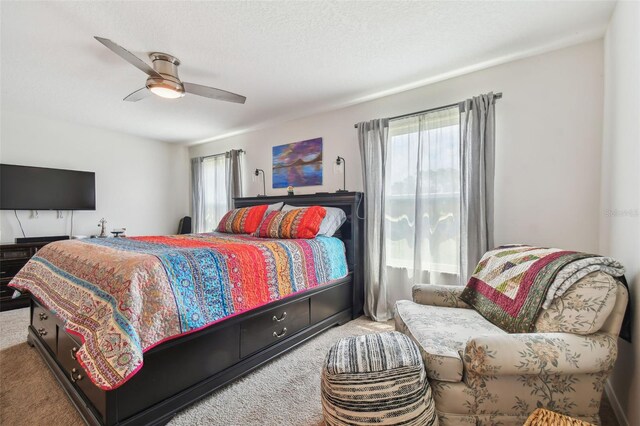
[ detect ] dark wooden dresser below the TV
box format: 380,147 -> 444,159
0,242 -> 48,311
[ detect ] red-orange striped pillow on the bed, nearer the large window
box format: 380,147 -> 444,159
253,206 -> 327,239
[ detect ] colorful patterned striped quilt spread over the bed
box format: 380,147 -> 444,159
9,232 -> 347,390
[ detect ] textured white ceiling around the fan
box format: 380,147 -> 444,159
0,1 -> 614,143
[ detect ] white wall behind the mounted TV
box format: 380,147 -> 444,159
0,111 -> 189,242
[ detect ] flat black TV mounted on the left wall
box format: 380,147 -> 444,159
0,164 -> 96,210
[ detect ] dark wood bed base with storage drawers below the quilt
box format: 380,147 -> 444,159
29,274 -> 353,425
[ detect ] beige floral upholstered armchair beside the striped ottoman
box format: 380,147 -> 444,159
395,272 -> 628,425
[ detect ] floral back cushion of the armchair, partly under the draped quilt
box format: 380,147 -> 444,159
535,271 -> 617,334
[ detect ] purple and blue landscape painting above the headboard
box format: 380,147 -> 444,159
273,138 -> 322,188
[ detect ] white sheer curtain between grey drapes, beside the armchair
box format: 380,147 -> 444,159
384,106 -> 460,311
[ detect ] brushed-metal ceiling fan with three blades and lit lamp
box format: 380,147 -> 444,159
94,37 -> 247,104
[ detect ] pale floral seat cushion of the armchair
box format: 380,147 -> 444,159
395,300 -> 506,382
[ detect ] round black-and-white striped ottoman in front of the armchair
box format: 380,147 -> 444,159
321,331 -> 438,426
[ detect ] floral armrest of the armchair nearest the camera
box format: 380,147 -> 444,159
463,333 -> 618,376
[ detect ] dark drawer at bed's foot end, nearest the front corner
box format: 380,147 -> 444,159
58,330 -> 106,418
